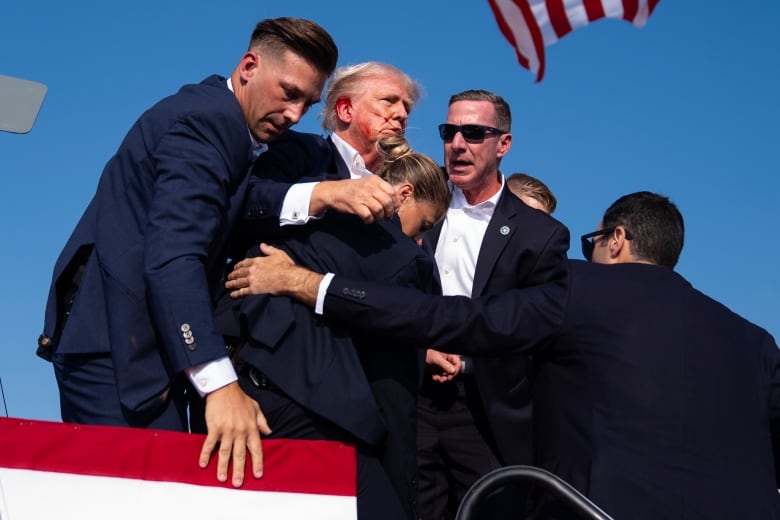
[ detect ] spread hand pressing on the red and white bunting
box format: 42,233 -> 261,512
198,382 -> 271,487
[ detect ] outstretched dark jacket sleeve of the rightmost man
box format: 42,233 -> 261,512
324,262 -> 569,355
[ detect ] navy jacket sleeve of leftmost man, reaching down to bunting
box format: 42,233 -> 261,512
144,109 -> 250,371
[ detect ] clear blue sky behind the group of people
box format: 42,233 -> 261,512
0,0 -> 780,420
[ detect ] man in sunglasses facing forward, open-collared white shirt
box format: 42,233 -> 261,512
417,90 -> 569,519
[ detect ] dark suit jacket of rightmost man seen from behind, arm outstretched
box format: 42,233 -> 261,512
325,261 -> 780,519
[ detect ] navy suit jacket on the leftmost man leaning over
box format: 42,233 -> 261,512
42,76 -> 252,413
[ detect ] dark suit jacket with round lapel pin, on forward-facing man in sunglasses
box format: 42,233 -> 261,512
426,186 -> 569,465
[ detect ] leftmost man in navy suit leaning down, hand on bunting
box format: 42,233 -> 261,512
38,18 -> 338,486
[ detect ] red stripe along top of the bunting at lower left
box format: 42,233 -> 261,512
0,417 -> 357,496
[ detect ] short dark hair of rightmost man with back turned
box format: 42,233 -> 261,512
602,191 -> 685,269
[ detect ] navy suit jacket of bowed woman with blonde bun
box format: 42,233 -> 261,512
225,213 -> 438,444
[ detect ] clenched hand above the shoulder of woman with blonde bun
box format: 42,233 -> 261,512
309,175 -> 400,224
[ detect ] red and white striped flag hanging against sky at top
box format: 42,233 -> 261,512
488,0 -> 660,81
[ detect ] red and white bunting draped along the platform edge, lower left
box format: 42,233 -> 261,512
0,418 -> 357,520
